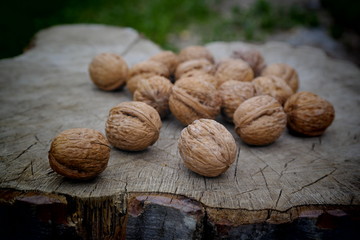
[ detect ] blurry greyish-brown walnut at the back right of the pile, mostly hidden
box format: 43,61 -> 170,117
232,48 -> 265,76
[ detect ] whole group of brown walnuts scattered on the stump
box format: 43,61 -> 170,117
49,46 -> 335,179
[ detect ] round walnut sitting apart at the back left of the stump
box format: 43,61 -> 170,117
89,53 -> 129,91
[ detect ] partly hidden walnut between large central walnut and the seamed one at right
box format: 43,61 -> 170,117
218,80 -> 255,122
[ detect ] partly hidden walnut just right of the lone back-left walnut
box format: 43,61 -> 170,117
126,61 -> 170,94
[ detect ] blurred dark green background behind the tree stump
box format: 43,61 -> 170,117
0,0 -> 359,58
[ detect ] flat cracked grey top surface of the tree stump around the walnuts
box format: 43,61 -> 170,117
0,25 -> 360,238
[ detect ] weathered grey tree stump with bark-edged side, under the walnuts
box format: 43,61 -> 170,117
0,25 -> 360,239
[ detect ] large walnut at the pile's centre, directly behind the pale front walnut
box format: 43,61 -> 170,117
169,77 -> 221,125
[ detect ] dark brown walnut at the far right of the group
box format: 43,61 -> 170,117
284,92 -> 335,136
